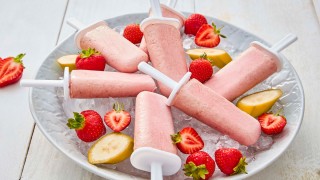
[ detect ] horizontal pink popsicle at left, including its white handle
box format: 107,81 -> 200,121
20,67 -> 156,99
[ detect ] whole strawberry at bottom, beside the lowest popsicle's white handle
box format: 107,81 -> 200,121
183,151 -> 215,180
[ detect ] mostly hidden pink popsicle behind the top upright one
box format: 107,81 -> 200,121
139,0 -> 186,54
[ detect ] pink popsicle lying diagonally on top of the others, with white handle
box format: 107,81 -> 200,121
138,62 -> 261,146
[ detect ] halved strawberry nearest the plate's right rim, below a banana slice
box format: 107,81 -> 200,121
258,109 -> 287,135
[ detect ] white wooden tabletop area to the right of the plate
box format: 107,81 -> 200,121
196,0 -> 320,179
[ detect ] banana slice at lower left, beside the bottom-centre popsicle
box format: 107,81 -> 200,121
88,133 -> 133,164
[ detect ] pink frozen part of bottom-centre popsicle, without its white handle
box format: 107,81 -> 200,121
134,91 -> 177,154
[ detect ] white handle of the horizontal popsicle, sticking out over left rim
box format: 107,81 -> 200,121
20,67 -> 70,100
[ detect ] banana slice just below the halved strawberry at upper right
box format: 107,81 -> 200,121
186,48 -> 232,69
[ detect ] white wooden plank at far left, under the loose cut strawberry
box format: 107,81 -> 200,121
0,0 -> 67,180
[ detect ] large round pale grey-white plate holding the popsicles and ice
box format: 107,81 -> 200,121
30,14 -> 304,180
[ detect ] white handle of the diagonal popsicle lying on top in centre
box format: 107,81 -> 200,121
138,62 -> 191,106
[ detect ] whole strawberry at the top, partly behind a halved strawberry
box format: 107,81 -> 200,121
184,14 -> 208,36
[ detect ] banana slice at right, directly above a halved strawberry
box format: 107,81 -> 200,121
237,89 -> 282,117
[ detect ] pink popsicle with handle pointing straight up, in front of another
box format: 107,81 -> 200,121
140,0 -> 187,96
